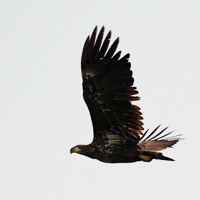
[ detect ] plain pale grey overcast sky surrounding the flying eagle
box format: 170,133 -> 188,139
0,0 -> 200,200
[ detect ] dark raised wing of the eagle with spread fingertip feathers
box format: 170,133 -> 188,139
81,27 -> 143,142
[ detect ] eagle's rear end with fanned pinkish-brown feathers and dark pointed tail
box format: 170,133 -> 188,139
138,126 -> 180,162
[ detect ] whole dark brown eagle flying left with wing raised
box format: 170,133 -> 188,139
70,26 -> 180,163
